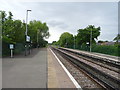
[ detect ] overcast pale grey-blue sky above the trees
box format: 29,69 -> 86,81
0,0 -> 118,43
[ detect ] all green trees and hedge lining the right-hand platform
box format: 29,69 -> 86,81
52,25 -> 120,56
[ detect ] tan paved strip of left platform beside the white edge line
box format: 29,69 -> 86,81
48,48 -> 76,88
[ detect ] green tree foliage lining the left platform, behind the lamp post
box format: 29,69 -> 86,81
0,11 -> 50,55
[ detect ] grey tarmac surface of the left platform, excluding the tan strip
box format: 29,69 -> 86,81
2,48 -> 47,88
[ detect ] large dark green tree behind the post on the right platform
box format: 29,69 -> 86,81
76,25 -> 100,46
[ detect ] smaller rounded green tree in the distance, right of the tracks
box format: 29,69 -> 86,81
59,32 -> 74,48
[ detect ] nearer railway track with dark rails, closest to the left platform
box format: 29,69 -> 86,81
52,48 -> 120,90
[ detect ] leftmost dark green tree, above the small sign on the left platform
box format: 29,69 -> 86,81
2,12 -> 25,44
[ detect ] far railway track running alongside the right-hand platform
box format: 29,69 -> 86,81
59,49 -> 120,80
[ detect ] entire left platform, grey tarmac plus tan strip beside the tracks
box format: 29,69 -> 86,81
2,48 -> 80,90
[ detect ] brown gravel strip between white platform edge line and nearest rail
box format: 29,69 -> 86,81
53,49 -> 103,90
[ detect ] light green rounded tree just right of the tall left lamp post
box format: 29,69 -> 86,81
28,20 -> 50,46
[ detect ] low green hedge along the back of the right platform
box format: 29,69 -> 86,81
72,44 -> 120,56
